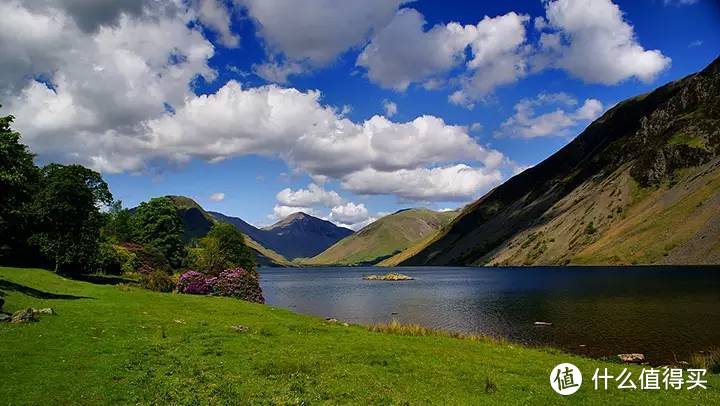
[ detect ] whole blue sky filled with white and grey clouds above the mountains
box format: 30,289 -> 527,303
0,0 -> 720,229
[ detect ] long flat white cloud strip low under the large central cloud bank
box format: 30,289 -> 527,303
343,164 -> 502,201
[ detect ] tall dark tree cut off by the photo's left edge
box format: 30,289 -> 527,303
0,111 -> 40,258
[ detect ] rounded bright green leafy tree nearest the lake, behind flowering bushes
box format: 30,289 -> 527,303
194,223 -> 255,273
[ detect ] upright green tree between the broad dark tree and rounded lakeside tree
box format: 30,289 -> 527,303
131,197 -> 187,268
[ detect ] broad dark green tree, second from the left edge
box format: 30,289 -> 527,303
31,164 -> 112,274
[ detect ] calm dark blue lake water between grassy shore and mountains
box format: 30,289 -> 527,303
261,267 -> 720,363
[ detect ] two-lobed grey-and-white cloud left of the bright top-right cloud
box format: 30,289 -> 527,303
357,9 -> 529,105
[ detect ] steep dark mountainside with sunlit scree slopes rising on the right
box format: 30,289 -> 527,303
384,58 -> 720,265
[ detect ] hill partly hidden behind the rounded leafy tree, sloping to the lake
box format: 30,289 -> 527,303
165,196 -> 294,266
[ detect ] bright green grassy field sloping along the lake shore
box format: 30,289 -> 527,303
0,268 -> 720,405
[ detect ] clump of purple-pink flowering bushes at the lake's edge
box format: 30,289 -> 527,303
177,268 -> 265,303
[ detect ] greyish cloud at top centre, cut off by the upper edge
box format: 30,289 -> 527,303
242,0 -> 405,66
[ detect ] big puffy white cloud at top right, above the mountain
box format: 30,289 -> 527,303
535,0 -> 670,85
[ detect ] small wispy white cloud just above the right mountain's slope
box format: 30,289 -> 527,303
495,93 -> 604,138
